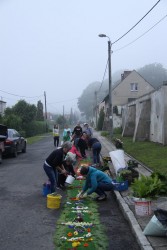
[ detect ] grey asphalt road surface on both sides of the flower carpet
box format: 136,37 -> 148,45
0,136 -> 140,250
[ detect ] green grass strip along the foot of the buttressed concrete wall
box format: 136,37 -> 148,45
111,134 -> 167,174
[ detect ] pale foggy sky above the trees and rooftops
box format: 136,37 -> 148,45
0,0 -> 167,113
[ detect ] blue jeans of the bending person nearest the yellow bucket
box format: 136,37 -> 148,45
43,163 -> 58,193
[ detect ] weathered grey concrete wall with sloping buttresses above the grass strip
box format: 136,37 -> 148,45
122,86 -> 167,145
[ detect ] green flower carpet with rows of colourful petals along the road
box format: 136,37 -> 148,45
54,161 -> 108,250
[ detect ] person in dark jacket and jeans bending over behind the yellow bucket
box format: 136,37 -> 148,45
43,141 -> 72,193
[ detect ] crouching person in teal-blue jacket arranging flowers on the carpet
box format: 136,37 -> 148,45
77,166 -> 113,201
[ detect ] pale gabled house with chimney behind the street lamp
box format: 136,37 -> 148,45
97,70 -> 154,130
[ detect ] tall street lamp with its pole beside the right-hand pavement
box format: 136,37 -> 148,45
99,34 -> 113,139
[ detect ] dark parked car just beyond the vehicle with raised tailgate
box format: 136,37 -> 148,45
3,128 -> 27,157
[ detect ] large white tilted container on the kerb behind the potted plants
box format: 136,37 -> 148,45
109,149 -> 126,174
